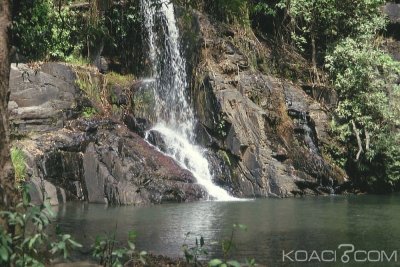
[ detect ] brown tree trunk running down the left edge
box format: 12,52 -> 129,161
0,0 -> 16,210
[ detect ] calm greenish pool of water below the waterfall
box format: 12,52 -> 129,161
57,195 -> 400,266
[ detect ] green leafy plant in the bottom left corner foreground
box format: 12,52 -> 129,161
0,186 -> 81,267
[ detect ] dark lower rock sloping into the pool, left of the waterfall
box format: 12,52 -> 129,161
15,120 -> 206,205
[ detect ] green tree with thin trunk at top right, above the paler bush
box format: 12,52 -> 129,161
255,0 -> 385,83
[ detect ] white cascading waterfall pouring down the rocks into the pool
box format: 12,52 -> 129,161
141,0 -> 236,201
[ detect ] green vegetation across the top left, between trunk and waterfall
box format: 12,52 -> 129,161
12,0 -> 140,72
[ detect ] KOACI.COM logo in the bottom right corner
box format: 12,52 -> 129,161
282,244 -> 397,264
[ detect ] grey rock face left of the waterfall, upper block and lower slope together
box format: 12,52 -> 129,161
9,63 -> 206,205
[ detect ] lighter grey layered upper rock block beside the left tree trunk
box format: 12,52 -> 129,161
8,63 -> 79,135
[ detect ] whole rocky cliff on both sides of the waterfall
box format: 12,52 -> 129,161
9,7 -> 346,205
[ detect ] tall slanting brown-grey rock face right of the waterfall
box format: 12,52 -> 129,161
185,14 -> 346,197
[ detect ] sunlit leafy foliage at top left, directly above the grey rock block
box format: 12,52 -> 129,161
12,0 -> 77,60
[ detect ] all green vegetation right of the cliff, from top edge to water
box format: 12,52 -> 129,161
252,0 -> 400,192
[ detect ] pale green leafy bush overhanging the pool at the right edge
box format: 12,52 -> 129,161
326,38 -> 400,192
